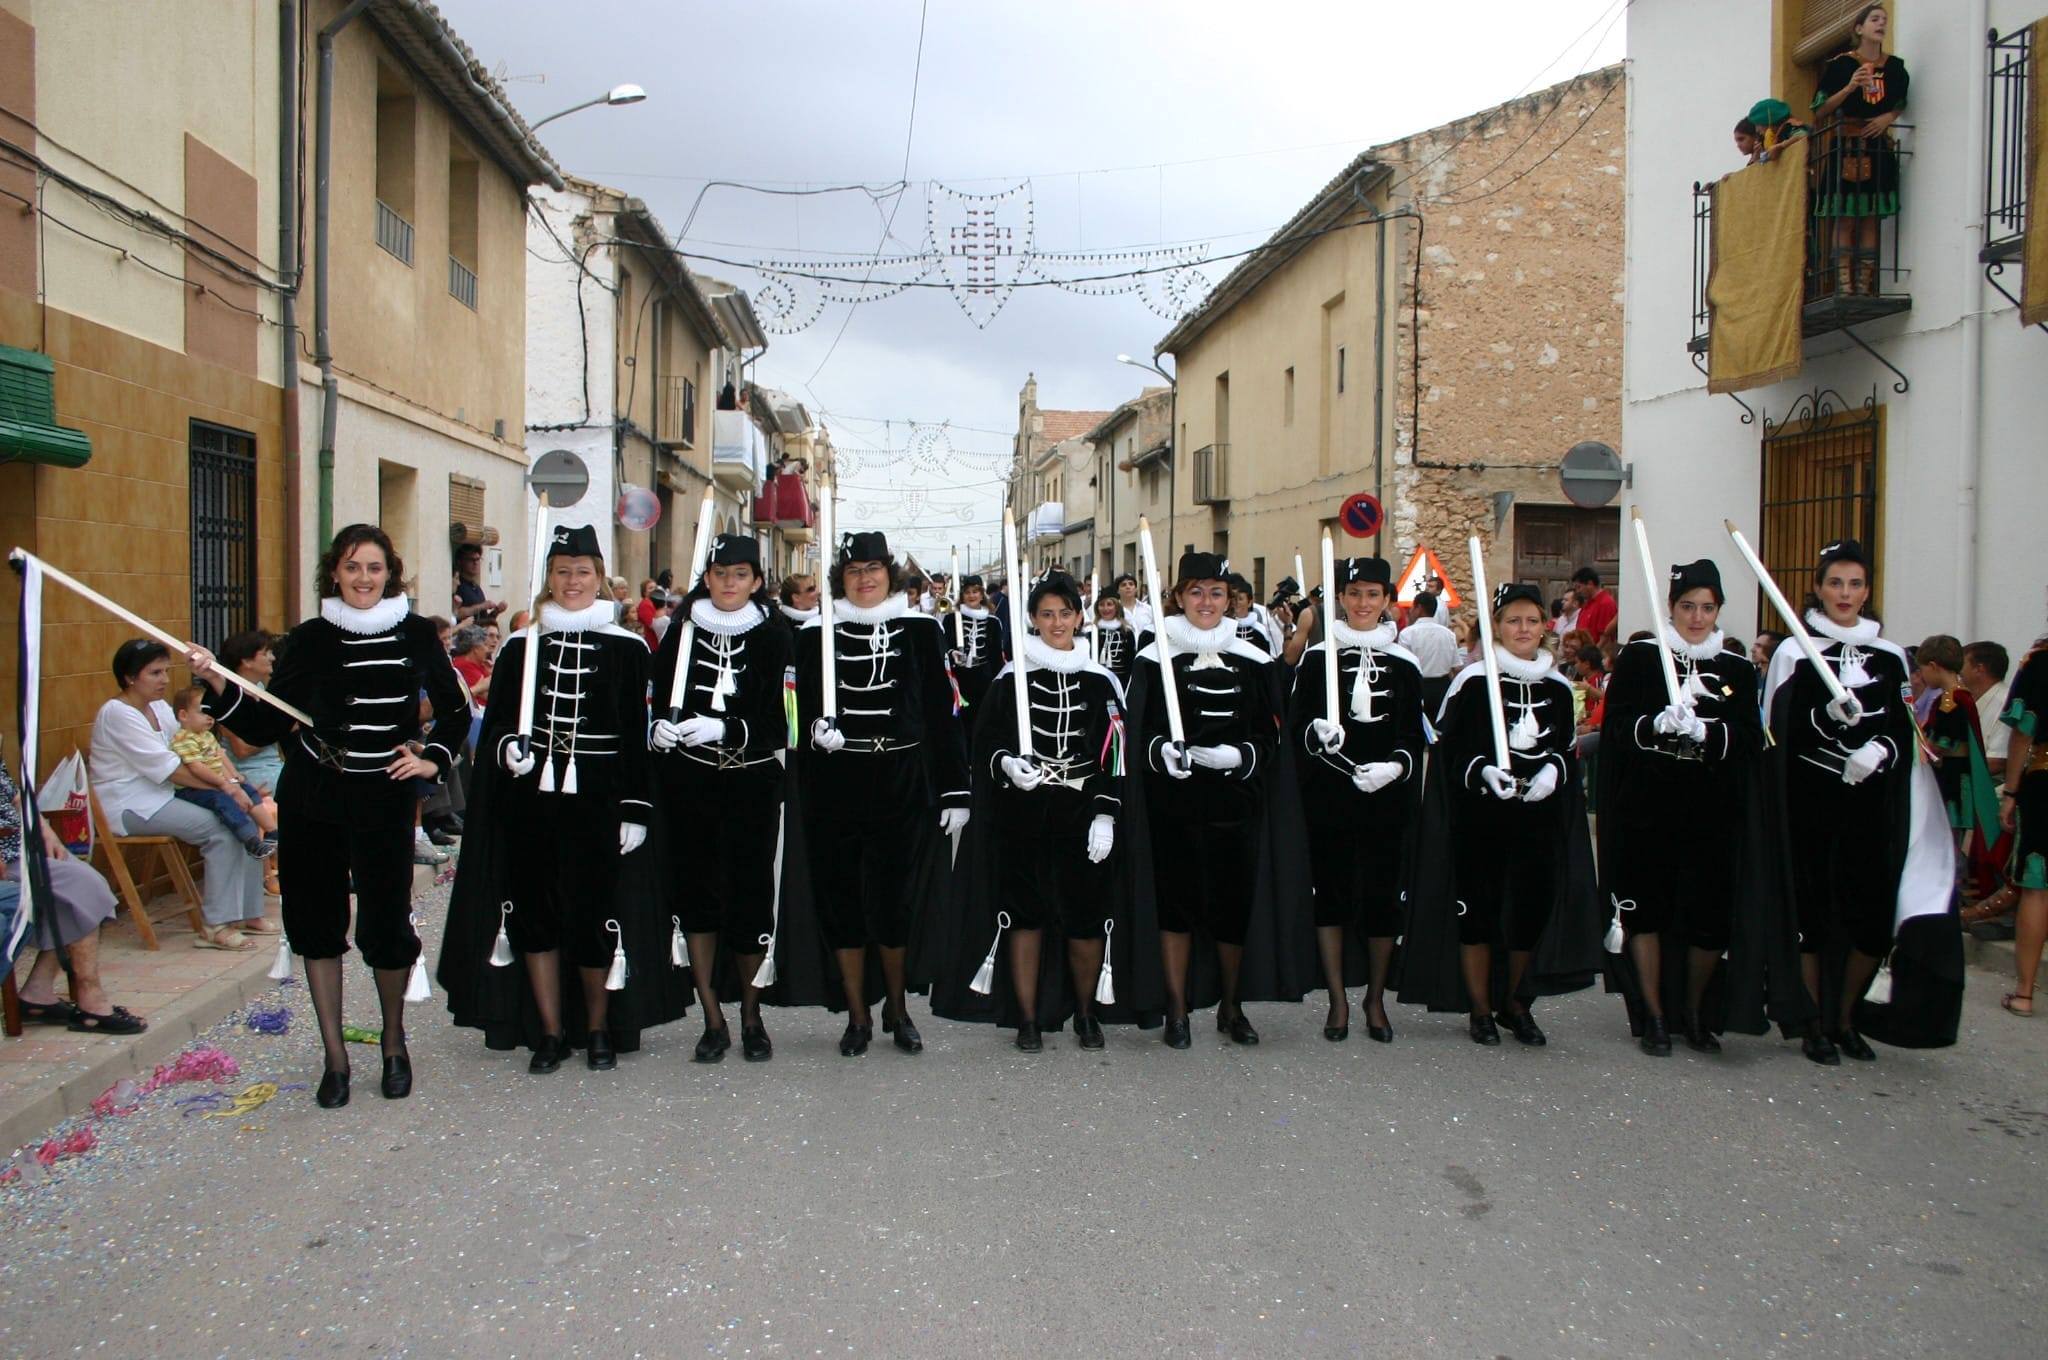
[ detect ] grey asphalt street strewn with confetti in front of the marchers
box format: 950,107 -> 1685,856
0,876 -> 2048,1358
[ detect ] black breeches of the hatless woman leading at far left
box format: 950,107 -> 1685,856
276,764 -> 420,969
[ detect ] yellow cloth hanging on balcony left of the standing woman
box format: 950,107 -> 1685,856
1706,137 -> 1806,391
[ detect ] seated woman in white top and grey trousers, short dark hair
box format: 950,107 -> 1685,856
92,637 -> 279,950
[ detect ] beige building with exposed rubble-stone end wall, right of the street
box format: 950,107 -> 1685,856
1155,66 -> 1624,614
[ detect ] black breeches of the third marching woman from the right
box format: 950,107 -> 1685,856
1452,795 -> 1565,952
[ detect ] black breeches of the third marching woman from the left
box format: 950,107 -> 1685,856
655,754 -> 782,954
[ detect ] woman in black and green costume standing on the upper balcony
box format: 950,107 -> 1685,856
1812,4 -> 1907,295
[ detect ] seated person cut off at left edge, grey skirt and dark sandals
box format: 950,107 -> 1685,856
0,745 -> 150,1034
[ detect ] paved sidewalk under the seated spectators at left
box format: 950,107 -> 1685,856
0,860 -> 440,1161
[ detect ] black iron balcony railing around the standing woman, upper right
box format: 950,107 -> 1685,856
1686,119 -> 1913,364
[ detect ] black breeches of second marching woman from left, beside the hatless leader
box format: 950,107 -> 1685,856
504,787 -> 621,969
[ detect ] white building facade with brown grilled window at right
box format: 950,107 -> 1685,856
1620,0 -> 2048,660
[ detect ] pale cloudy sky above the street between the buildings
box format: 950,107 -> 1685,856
440,0 -> 1630,569
